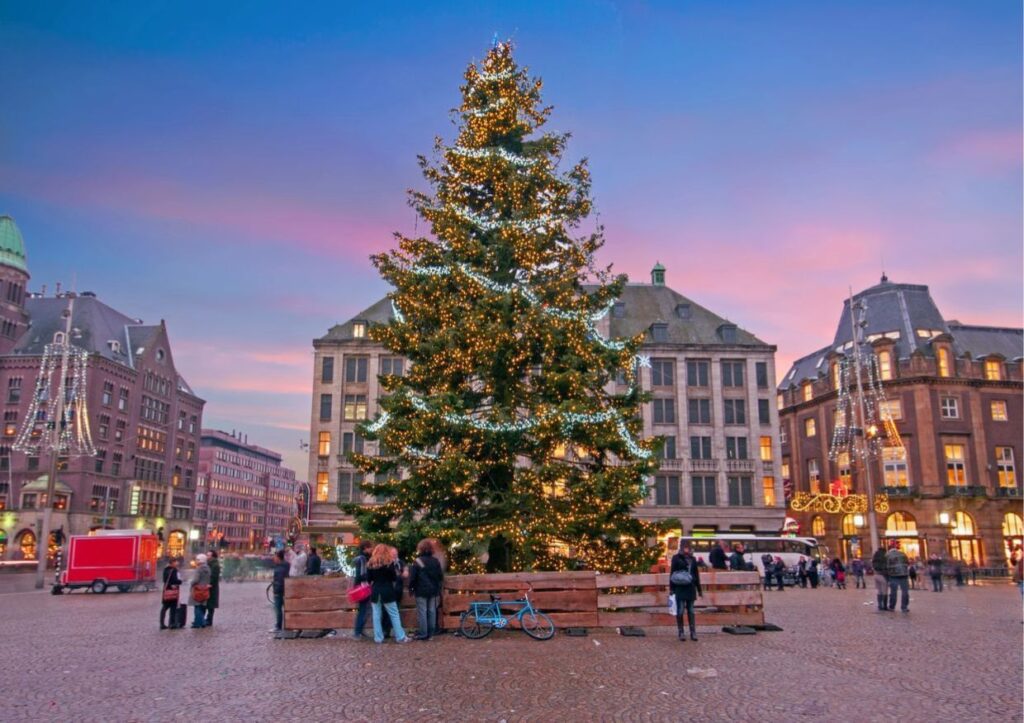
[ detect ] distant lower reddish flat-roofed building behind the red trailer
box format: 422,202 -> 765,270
196,429 -> 302,552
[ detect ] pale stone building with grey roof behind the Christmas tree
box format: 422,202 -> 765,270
309,264 -> 784,542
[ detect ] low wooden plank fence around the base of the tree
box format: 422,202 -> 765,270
285,570 -> 765,630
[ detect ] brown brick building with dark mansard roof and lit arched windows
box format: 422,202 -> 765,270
778,277 -> 1024,567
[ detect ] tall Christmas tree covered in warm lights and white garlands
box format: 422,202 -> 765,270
344,43 -> 659,571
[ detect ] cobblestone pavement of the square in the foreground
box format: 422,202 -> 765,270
0,573 -> 1024,721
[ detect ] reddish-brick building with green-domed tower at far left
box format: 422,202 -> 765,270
0,219 -> 205,559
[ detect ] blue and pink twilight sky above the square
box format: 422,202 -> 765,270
0,0 -> 1024,477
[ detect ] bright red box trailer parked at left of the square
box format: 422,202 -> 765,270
53,529 -> 160,595
